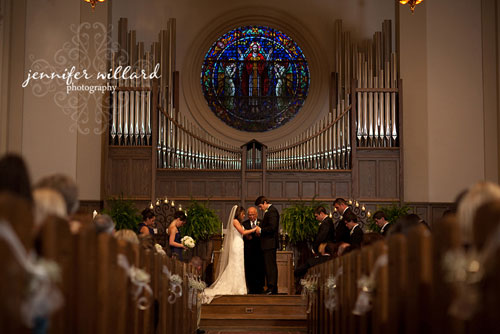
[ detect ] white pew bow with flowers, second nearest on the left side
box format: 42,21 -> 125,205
118,254 -> 153,311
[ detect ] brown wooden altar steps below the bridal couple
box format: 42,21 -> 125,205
200,295 -> 307,332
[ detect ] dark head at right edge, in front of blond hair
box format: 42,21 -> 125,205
473,200 -> 500,250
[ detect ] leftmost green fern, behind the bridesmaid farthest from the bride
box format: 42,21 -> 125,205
103,196 -> 142,232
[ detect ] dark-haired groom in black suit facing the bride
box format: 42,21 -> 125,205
255,196 -> 280,295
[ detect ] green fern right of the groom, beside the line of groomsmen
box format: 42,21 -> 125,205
281,200 -> 327,245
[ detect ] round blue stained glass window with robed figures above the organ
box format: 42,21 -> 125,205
201,26 -> 310,132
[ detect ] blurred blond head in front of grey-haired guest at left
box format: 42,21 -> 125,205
33,188 -> 67,228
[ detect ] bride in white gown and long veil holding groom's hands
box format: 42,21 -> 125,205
202,205 -> 257,304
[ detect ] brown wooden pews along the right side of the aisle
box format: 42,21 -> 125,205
302,219 -> 500,334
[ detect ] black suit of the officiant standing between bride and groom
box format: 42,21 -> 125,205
242,219 -> 265,294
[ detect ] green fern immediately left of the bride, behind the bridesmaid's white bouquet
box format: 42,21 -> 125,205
181,200 -> 221,242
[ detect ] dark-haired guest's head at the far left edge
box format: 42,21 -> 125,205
0,154 -> 33,202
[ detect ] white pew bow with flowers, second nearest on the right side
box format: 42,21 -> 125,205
352,254 -> 389,315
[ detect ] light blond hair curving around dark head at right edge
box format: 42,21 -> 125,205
457,182 -> 500,244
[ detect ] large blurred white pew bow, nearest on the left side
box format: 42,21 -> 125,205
0,221 -> 64,328
